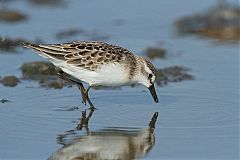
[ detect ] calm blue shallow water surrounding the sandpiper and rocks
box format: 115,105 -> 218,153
0,0 -> 239,160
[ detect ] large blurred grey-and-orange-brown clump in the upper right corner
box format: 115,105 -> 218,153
175,1 -> 240,42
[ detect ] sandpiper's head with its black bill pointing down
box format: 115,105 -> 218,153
135,57 -> 158,103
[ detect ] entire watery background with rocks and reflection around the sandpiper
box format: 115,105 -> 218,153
0,0 -> 240,160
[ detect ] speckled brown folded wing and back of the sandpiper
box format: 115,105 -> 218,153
24,41 -> 136,70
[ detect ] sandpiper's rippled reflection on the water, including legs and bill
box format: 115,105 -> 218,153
49,111 -> 158,160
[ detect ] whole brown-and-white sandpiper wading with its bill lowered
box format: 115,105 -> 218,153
23,41 -> 158,109
